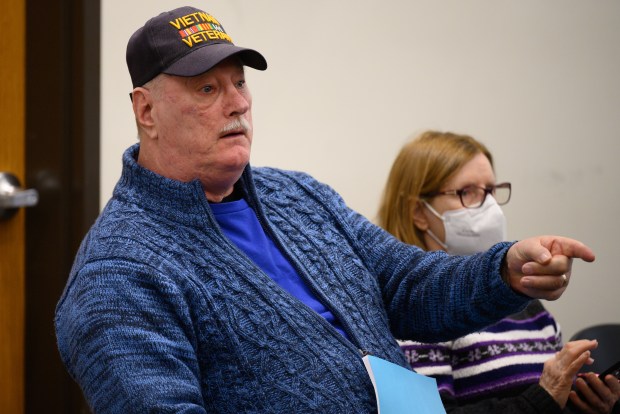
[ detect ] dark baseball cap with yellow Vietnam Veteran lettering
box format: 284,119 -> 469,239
126,6 -> 267,88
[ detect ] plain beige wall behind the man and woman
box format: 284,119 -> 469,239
101,0 -> 620,338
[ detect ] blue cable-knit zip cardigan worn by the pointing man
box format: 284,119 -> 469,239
55,144 -> 528,413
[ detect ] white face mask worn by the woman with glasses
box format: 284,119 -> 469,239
423,195 -> 506,255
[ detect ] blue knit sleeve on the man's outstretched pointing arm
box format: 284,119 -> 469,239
314,177 -> 531,342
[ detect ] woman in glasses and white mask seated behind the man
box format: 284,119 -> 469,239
379,131 -> 620,413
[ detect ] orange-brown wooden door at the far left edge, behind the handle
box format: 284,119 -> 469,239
0,0 -> 26,414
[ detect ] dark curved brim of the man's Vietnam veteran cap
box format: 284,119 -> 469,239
162,43 -> 267,76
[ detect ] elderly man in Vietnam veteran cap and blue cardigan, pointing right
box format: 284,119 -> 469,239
55,7 -> 594,413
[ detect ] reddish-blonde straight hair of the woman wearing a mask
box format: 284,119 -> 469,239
378,131 -> 493,250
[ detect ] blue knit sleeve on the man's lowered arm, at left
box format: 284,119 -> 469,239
55,259 -> 205,413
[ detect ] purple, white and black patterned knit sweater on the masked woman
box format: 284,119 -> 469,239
399,300 -> 562,413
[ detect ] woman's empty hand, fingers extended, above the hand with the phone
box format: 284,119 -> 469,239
538,339 -> 598,408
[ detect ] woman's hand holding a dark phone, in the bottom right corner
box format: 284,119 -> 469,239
570,372 -> 620,414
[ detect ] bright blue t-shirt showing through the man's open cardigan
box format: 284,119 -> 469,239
210,199 -> 348,338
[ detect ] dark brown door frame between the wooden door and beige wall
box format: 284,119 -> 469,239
21,0 -> 101,413
